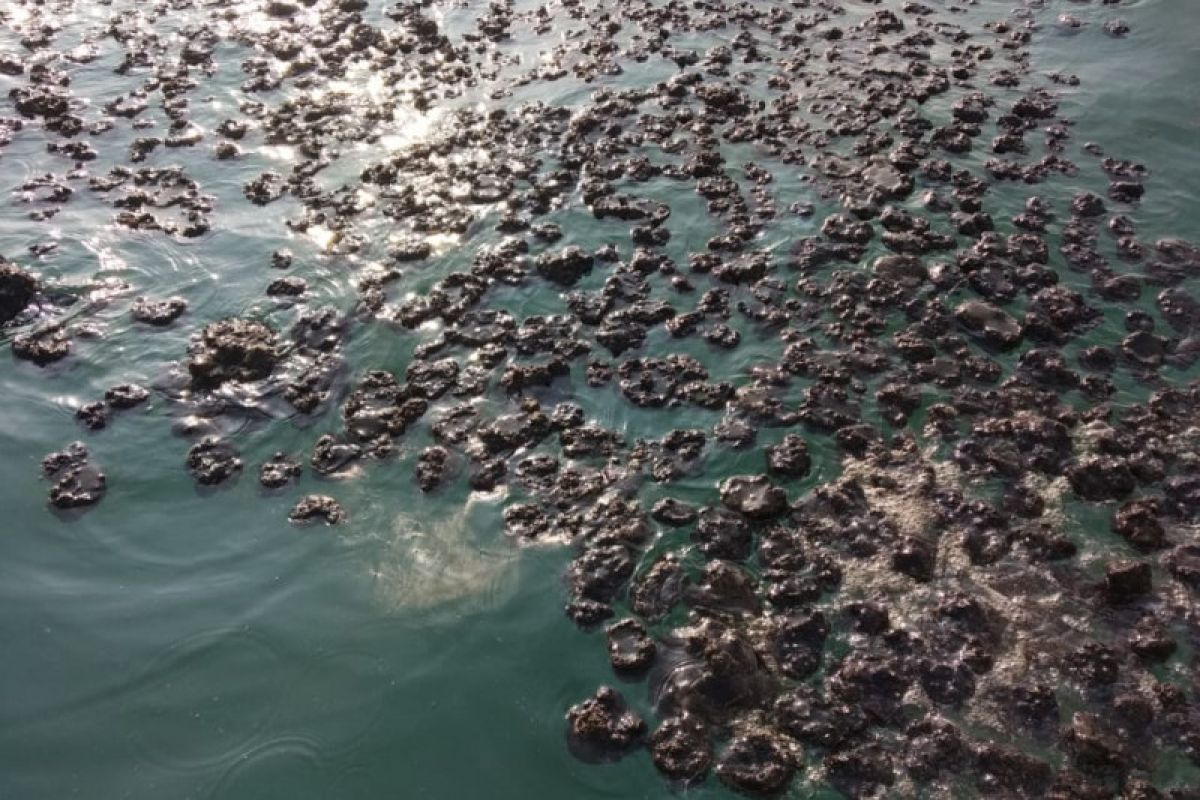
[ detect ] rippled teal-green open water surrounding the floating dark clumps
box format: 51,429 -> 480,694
0,0 -> 1200,799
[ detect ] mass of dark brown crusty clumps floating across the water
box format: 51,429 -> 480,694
0,0 -> 1200,800
